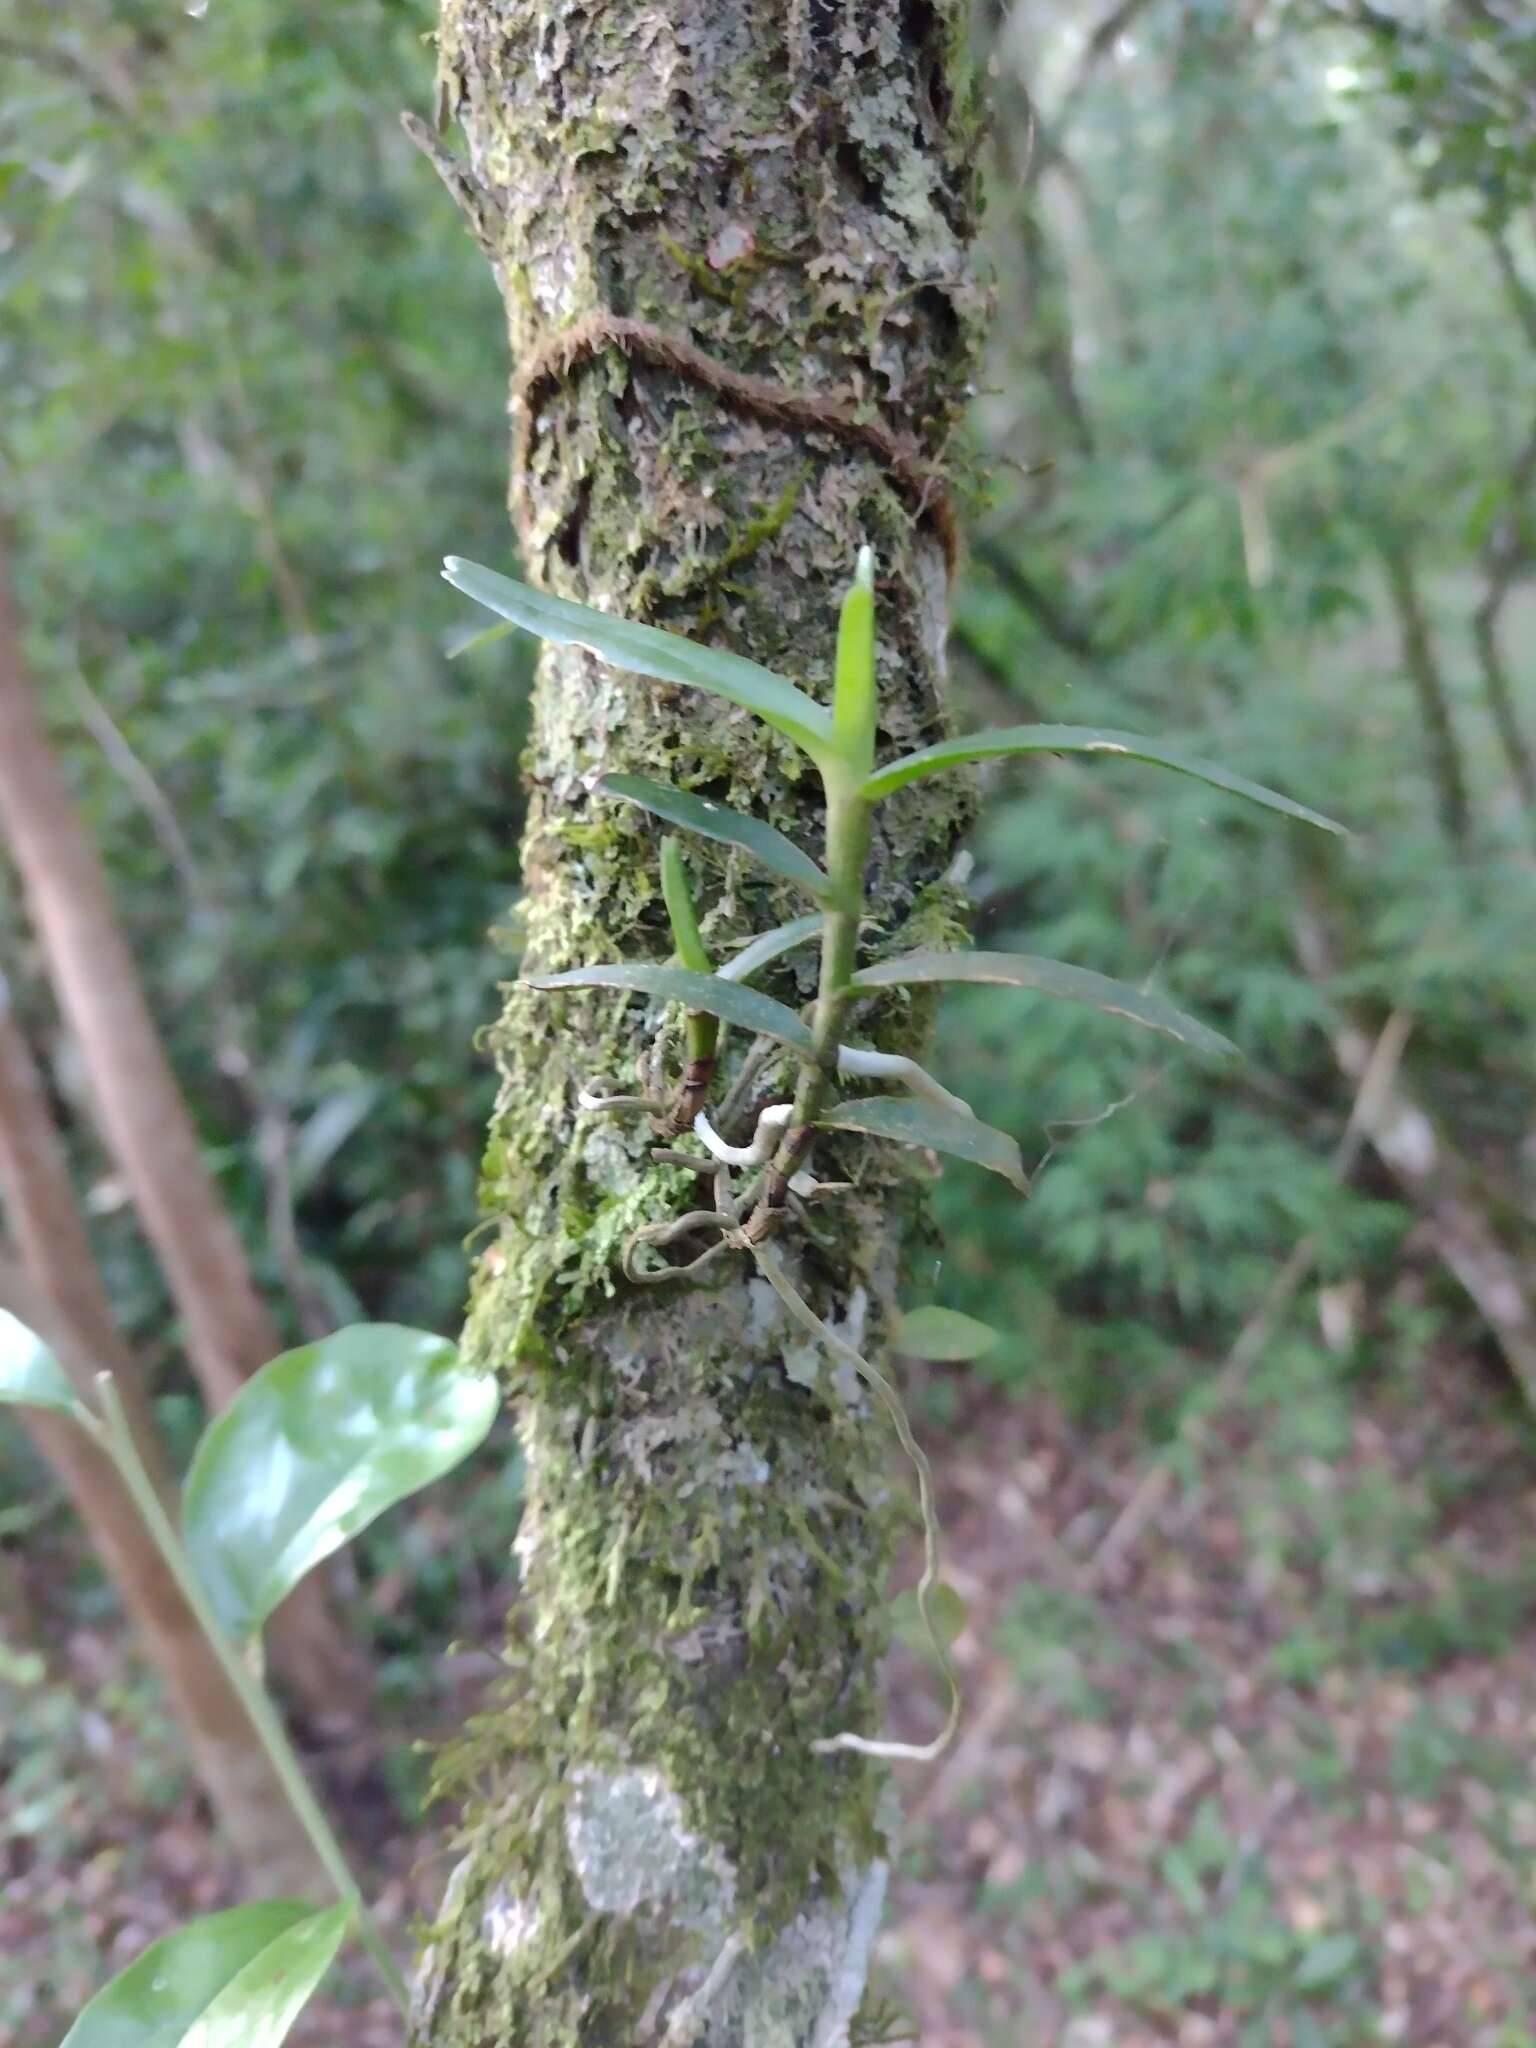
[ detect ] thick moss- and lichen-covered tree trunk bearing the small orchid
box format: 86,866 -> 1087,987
416,0 -> 983,2048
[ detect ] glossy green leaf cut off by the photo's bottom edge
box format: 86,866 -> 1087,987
61,1901 -> 350,2048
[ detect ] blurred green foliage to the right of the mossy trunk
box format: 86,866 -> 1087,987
936,6 -> 1536,1421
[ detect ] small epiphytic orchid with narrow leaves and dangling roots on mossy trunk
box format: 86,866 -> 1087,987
442,549 -> 1341,1757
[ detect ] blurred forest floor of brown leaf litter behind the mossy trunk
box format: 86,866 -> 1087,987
0,1368 -> 1536,2048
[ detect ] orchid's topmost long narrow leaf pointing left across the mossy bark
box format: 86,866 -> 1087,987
442,555 -> 831,756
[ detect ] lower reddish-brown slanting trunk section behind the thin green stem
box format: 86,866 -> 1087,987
0,1261 -> 334,1903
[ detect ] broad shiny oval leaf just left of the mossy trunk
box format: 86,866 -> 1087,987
182,1323 -> 500,1638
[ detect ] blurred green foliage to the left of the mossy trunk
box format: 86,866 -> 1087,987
0,0 -> 526,1368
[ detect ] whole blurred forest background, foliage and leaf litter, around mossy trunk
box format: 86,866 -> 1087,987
0,0 -> 1536,2048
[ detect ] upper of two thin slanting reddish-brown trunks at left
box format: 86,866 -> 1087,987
0,553 -> 367,1722
